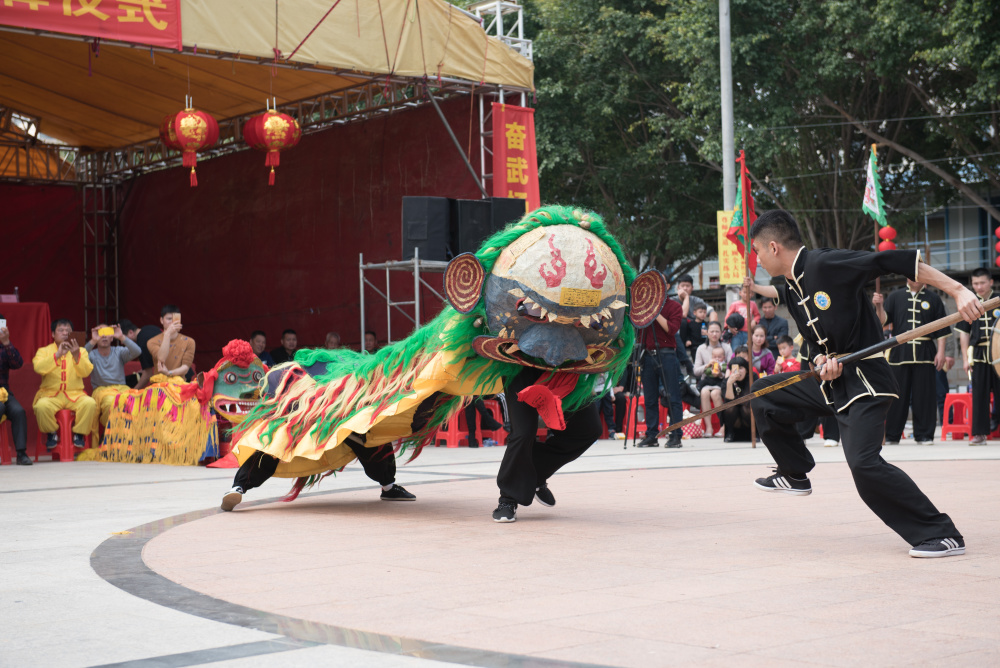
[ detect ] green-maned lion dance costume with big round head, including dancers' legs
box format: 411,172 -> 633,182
222,206 -> 666,521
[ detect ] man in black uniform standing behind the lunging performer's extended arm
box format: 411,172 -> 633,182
872,279 -> 951,445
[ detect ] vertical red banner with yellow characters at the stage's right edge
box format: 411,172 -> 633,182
493,102 -> 542,211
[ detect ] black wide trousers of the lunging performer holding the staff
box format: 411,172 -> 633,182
750,373 -> 961,545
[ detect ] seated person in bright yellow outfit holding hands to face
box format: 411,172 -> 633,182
31,319 -> 97,450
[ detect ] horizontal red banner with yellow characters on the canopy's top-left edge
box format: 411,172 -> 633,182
0,0 -> 182,51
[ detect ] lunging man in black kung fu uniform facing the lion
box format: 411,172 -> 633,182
745,211 -> 982,557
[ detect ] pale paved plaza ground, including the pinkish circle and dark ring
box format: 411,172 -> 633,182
0,439 -> 1000,668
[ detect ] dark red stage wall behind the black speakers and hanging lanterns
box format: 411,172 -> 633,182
119,98 -> 480,370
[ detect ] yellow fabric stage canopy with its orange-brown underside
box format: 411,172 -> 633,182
0,0 -> 534,149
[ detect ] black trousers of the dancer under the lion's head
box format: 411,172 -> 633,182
497,368 -> 601,506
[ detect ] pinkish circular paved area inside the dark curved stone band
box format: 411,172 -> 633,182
143,461 -> 1000,668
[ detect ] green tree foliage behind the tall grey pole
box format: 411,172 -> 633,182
527,0 -> 1000,271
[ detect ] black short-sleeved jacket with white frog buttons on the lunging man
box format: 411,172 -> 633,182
777,247 -> 920,411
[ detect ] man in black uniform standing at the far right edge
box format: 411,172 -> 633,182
955,268 -> 1000,445
